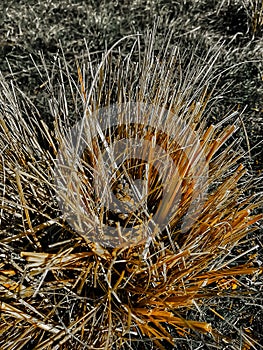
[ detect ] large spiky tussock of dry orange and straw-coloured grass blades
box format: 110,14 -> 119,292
0,28 -> 262,350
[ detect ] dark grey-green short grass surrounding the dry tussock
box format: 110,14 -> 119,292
0,0 -> 263,349
